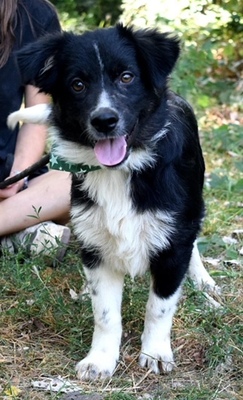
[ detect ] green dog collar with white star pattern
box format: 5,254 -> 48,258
50,152 -> 101,174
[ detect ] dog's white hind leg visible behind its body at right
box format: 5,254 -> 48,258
188,242 -> 220,294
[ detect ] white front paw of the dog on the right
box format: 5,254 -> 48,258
139,351 -> 175,374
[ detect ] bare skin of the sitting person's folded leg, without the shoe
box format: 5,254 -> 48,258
0,171 -> 71,237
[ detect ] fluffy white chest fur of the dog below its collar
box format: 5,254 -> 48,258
71,170 -> 173,277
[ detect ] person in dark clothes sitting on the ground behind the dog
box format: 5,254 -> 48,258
0,0 -> 71,259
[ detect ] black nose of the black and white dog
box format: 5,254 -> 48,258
91,108 -> 119,133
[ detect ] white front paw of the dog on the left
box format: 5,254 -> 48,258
76,352 -> 116,381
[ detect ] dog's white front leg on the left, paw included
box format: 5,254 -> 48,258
76,265 -> 124,380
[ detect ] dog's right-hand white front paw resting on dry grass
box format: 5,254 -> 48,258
139,346 -> 175,374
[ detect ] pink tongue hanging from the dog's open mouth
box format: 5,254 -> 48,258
94,136 -> 127,165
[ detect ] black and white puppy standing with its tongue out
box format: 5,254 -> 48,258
9,25 -> 218,379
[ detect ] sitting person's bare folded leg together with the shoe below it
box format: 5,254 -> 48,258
0,171 -> 71,260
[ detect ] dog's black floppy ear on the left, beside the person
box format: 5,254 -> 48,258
16,33 -> 65,93
